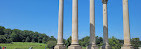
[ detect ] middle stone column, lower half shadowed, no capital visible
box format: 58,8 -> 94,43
87,0 -> 98,49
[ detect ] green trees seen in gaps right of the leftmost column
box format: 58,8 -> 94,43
64,36 -> 141,49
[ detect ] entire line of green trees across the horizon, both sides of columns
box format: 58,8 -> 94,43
0,26 -> 141,49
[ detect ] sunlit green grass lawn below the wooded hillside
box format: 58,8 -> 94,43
0,42 -> 47,49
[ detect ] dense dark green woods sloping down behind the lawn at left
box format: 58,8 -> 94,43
0,26 -> 56,43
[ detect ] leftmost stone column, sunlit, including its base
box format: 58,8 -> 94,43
54,0 -> 66,49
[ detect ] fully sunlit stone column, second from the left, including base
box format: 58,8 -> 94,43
68,0 -> 82,49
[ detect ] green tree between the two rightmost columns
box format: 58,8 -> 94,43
109,37 -> 121,49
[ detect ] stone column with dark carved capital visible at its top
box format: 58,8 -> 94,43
102,0 -> 110,49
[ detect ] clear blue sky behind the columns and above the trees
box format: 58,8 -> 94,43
0,0 -> 141,39
